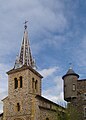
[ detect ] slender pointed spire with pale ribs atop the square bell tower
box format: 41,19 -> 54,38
15,21 -> 34,68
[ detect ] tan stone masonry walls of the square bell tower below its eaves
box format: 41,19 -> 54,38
3,69 -> 41,120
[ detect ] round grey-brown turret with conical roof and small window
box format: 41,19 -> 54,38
62,68 -> 79,102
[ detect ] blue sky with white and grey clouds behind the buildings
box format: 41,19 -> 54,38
0,0 -> 86,112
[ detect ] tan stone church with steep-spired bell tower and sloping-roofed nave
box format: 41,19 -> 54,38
0,22 -> 65,120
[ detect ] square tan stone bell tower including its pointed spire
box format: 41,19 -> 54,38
3,21 -> 42,120
